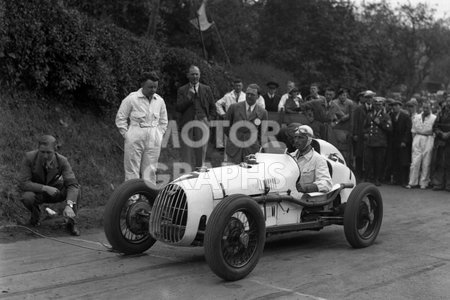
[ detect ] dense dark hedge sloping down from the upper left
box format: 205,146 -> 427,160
0,0 -> 232,108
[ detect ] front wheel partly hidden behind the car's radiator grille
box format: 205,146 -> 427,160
103,179 -> 158,254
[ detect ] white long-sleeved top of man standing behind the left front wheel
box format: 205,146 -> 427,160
116,88 -> 168,136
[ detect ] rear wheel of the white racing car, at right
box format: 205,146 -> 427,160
344,183 -> 383,248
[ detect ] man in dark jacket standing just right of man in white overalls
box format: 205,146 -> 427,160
175,66 -> 216,169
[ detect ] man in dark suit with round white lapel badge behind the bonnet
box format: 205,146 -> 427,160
225,84 -> 267,163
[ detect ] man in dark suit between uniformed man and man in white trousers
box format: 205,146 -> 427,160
390,100 -> 412,186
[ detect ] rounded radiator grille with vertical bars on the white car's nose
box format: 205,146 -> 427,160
150,184 -> 188,244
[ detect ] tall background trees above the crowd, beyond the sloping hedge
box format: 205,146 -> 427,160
66,0 -> 450,94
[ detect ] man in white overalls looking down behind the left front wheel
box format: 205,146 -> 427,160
116,72 -> 168,184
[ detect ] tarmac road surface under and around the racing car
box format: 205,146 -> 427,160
0,186 -> 450,300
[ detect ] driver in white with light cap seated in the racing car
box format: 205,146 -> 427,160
292,125 -> 333,193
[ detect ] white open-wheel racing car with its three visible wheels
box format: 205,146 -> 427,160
104,139 -> 383,281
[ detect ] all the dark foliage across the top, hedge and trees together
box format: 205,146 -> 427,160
0,0 -> 450,106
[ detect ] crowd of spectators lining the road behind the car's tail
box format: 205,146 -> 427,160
217,81 -> 450,191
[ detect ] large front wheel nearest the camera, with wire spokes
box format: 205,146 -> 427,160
204,194 -> 266,281
